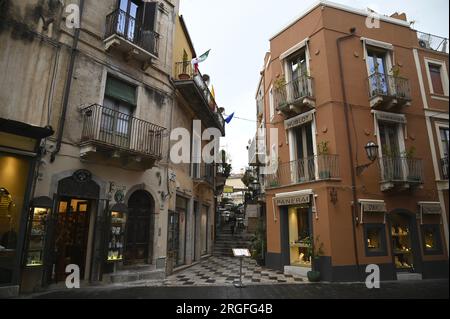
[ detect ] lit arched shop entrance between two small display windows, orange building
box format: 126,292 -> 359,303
389,213 -> 421,272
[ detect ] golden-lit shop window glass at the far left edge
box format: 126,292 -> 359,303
0,153 -> 30,285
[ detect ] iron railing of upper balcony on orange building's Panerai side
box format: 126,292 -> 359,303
274,75 -> 314,110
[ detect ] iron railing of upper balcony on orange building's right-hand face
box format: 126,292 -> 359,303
368,73 -> 411,100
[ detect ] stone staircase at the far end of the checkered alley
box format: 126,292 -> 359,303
213,224 -> 252,257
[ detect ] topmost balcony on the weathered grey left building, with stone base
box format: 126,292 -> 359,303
103,9 -> 159,63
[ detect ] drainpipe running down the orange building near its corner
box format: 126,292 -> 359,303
336,27 -> 361,278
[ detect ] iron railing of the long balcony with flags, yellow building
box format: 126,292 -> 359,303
175,61 -> 225,132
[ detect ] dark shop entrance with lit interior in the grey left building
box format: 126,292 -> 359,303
54,198 -> 92,282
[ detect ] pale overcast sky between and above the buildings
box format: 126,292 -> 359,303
180,0 -> 449,172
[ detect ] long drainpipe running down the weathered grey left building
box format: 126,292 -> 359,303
50,0 -> 84,163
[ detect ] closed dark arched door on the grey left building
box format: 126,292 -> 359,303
125,190 -> 155,264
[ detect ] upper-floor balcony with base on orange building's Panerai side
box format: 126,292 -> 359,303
274,75 -> 315,117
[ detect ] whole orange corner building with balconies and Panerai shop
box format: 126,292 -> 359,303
257,2 -> 449,281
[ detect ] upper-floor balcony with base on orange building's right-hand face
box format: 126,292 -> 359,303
368,73 -> 411,110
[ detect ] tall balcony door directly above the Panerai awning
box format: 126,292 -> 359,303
291,123 -> 315,183
